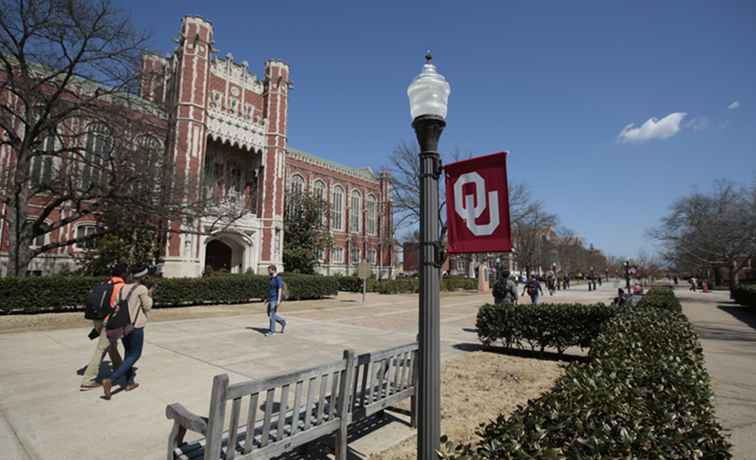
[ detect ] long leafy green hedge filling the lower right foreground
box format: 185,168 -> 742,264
441,292 -> 731,459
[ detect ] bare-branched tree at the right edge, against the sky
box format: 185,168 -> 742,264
649,180 -> 756,288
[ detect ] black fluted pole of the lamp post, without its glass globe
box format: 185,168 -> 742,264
412,115 -> 446,460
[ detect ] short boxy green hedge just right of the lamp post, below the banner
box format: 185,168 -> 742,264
477,304 -> 618,354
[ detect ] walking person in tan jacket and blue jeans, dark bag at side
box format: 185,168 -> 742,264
102,267 -> 155,400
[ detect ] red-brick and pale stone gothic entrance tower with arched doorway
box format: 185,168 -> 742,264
141,16 -> 291,277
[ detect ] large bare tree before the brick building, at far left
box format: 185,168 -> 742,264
0,0 -> 244,276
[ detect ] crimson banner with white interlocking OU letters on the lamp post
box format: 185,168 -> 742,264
444,152 -> 512,254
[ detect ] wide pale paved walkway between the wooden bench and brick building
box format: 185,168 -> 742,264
0,284 -> 611,459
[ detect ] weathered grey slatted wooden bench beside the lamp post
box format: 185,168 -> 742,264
165,343 -> 417,460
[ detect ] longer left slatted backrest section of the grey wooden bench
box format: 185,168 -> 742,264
204,350 -> 355,460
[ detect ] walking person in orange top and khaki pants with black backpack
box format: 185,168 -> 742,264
79,263 -> 128,391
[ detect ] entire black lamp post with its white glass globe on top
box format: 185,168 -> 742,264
407,51 -> 450,460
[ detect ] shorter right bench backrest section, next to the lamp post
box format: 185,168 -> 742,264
351,342 -> 418,419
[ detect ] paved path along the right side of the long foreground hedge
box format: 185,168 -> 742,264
676,289 -> 756,459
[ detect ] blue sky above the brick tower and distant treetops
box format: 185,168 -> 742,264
118,0 -> 756,256
